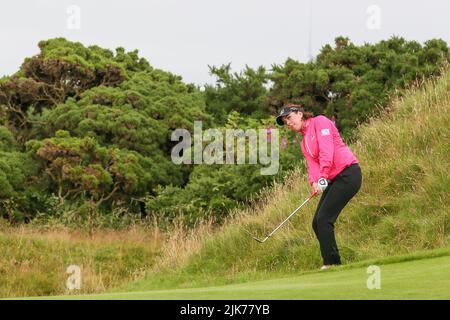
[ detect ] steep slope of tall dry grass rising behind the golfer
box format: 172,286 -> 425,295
120,72 -> 450,290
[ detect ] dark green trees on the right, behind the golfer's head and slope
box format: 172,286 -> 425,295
268,36 -> 450,137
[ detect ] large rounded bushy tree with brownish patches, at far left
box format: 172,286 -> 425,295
0,38 -> 211,224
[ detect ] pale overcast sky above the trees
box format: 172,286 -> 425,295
0,0 -> 450,85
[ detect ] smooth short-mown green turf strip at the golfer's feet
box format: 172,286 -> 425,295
38,252 -> 450,300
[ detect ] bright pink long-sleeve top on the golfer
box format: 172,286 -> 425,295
300,115 -> 358,185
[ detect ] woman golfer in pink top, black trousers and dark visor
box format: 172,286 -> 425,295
276,104 -> 362,270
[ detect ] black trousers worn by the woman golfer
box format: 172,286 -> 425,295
312,164 -> 362,265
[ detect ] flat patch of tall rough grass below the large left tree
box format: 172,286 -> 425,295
0,225 -> 164,298
